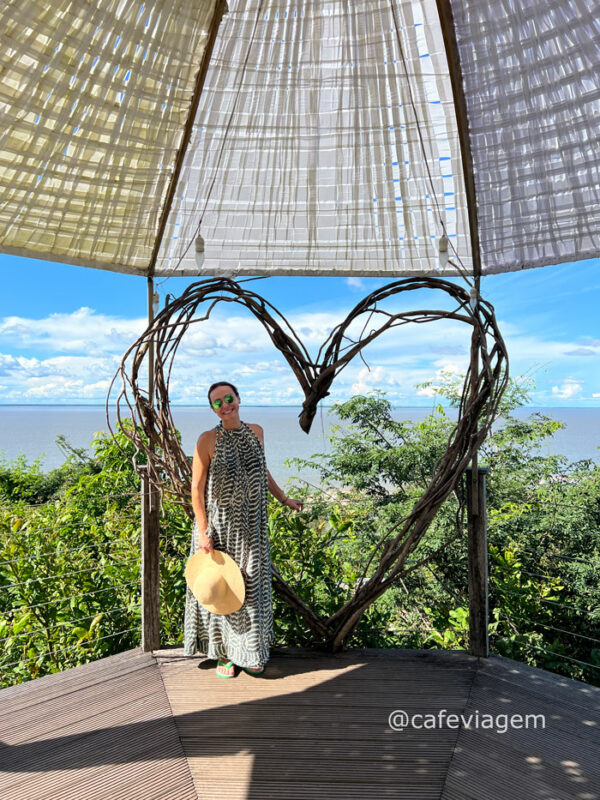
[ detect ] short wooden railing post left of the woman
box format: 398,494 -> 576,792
141,467 -> 160,653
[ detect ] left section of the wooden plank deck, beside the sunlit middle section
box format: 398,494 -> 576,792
0,650 -> 196,800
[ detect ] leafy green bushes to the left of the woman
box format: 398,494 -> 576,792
0,424 -> 190,686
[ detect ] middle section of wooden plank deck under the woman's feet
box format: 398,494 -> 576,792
158,651 -> 477,800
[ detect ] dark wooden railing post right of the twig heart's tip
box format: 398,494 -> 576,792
466,467 -> 490,658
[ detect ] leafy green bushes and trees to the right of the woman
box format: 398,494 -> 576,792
271,379 -> 600,683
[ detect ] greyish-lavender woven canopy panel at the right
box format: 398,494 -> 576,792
452,0 -> 600,273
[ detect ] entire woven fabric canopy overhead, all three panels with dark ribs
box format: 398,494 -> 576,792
0,0 -> 600,277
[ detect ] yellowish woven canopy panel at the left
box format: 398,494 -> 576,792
0,0 -> 215,274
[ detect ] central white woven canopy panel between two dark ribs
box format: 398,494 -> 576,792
158,0 -> 471,276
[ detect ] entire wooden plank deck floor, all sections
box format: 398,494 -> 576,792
0,650 -> 600,800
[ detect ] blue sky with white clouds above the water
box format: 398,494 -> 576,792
0,255 -> 600,407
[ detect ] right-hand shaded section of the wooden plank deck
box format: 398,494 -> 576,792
442,656 -> 600,800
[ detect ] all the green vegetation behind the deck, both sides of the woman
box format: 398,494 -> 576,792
0,382 -> 600,686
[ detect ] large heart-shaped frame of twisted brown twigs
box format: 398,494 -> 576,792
109,278 -> 508,649
